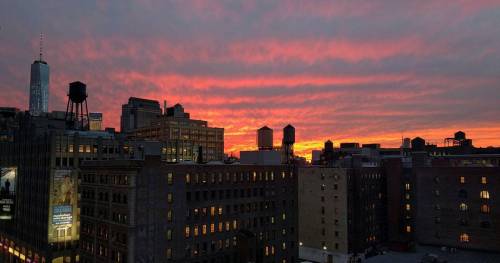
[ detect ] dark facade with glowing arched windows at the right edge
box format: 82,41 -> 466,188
416,165 -> 500,252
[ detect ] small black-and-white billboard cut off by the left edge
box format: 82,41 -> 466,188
0,167 -> 17,220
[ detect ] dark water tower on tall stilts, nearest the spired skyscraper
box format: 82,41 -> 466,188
65,81 -> 89,130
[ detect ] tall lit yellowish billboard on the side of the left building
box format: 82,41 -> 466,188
49,170 -> 78,243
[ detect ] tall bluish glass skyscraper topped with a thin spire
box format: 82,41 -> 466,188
29,37 -> 49,116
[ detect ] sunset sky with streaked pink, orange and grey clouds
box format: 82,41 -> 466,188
0,0 -> 500,159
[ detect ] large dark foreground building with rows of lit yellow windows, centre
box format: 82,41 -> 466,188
80,156 -> 298,263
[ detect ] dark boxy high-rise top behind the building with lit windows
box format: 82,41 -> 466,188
120,97 -> 161,133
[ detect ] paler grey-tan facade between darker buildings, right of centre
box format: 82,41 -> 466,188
298,166 -> 349,262
